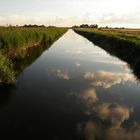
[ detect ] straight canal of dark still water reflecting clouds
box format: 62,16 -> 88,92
0,30 -> 140,140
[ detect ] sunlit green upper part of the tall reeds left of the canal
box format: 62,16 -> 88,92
0,27 -> 66,49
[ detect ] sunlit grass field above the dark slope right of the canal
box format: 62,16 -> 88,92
74,28 -> 140,46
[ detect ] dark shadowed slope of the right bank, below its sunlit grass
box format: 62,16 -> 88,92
73,29 -> 140,80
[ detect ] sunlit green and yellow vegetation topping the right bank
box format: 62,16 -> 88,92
74,28 -> 140,46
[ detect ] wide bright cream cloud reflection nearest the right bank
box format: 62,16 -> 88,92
84,71 -> 134,88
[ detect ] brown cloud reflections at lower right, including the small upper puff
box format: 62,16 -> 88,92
73,88 -> 140,140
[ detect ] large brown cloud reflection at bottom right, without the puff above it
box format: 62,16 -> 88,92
79,103 -> 140,140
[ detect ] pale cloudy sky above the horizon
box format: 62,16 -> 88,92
0,0 -> 140,28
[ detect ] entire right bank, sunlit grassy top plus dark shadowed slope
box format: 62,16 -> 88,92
74,29 -> 140,79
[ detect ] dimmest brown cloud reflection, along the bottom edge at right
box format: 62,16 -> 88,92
81,120 -> 140,140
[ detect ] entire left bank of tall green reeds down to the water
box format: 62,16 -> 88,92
0,27 -> 67,85
